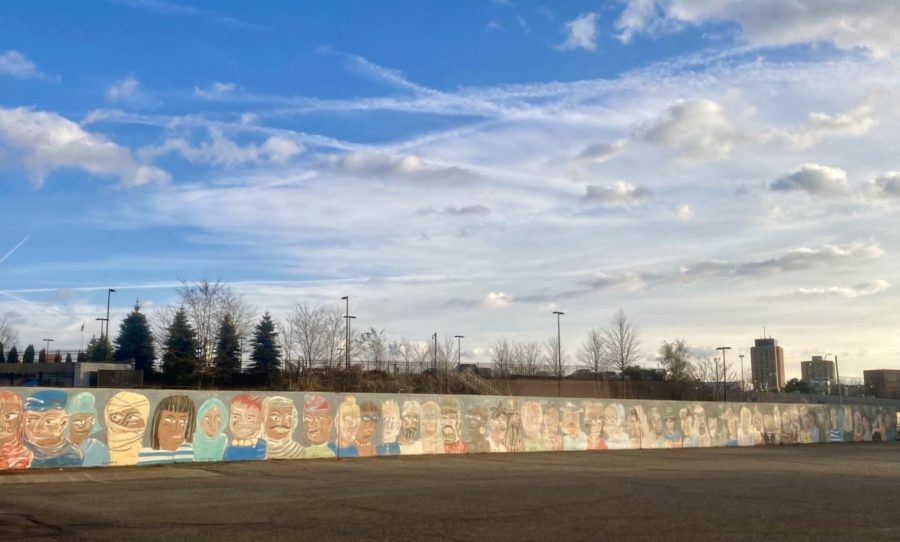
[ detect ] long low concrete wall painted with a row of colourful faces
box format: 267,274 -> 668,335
0,388 -> 897,470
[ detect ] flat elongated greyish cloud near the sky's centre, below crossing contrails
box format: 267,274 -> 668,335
331,151 -> 475,187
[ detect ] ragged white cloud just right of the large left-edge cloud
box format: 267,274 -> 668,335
140,128 -> 305,168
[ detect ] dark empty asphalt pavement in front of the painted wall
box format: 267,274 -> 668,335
0,443 -> 900,542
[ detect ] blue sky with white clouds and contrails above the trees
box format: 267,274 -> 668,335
0,0 -> 900,378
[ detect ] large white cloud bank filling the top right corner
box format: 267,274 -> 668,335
616,0 -> 900,57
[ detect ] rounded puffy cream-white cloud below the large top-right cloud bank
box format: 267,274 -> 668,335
638,99 -> 738,161
